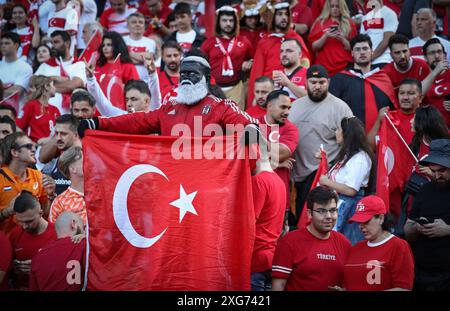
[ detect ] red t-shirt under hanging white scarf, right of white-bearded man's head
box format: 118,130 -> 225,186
200,35 -> 254,86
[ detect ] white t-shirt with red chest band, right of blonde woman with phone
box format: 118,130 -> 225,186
360,6 -> 398,64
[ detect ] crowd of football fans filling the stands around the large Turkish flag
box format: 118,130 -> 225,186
0,0 -> 450,291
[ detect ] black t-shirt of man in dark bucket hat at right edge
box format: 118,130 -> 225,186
409,181 -> 450,277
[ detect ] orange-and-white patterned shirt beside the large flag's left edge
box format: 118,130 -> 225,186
49,187 -> 86,224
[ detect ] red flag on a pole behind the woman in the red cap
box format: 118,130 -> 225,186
376,116 -> 417,217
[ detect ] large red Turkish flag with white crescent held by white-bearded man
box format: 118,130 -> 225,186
83,131 -> 255,290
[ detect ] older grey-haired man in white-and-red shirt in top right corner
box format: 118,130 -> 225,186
409,8 -> 450,60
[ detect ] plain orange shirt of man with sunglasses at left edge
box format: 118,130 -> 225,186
0,166 -> 48,234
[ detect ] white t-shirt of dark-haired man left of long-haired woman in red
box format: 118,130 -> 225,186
35,60 -> 86,114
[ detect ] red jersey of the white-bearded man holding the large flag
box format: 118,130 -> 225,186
99,95 -> 258,137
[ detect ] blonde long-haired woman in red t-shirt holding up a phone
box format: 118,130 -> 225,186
309,0 -> 357,76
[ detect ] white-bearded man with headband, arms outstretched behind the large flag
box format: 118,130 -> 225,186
78,54 -> 258,137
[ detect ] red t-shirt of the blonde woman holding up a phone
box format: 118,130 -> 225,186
308,18 -> 357,76
